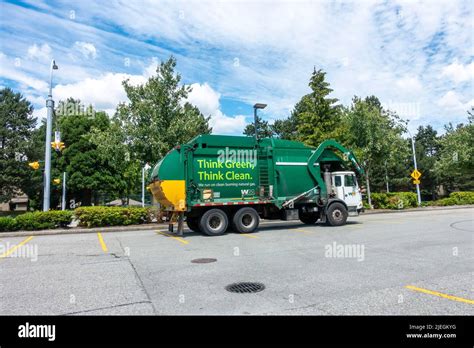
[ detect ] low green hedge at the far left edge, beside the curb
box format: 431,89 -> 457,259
0,210 -> 73,232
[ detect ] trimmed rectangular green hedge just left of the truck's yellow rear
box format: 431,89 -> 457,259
74,207 -> 153,227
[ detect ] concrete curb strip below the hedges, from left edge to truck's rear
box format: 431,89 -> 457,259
0,223 -> 168,238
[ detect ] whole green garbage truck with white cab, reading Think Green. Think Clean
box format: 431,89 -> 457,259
149,135 -> 364,236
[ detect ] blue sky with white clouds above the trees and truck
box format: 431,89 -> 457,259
0,0 -> 474,134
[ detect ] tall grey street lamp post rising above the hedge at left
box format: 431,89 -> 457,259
43,59 -> 58,211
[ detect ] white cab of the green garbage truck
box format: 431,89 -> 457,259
331,171 -> 363,216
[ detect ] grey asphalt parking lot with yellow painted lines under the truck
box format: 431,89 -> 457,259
0,209 -> 474,315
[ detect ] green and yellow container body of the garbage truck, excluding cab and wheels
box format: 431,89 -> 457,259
150,135 -> 363,232
